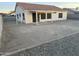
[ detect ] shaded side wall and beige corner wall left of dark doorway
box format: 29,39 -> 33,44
16,6 -> 32,23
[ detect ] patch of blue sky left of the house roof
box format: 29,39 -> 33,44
0,2 -> 16,12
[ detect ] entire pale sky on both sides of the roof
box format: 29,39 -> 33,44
0,2 -> 79,13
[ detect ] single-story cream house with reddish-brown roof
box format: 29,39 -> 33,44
15,2 -> 67,24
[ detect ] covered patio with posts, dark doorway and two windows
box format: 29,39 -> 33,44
30,10 -> 56,23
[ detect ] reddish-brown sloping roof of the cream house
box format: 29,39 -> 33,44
16,2 -> 63,11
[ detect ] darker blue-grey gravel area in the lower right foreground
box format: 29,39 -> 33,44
12,33 -> 79,56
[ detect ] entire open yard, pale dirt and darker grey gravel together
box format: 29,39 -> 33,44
3,20 -> 79,55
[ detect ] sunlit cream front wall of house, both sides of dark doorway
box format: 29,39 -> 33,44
25,10 -> 67,23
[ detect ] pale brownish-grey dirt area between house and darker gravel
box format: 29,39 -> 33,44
3,20 -> 79,52
